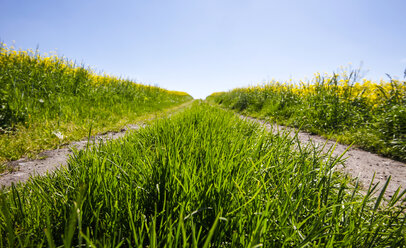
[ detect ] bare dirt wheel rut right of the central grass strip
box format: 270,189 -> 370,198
241,116 -> 406,198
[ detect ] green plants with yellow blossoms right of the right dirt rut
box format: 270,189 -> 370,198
207,70 -> 406,161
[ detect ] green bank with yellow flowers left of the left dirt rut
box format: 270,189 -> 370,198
0,44 -> 192,165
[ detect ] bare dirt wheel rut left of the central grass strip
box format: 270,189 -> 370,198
0,100 -> 194,188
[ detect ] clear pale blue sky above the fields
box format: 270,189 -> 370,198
0,0 -> 406,98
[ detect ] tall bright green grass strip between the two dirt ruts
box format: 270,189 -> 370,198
0,103 -> 406,247
